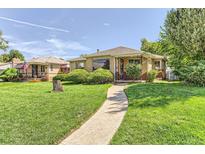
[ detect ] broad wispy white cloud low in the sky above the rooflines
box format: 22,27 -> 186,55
4,35 -> 89,60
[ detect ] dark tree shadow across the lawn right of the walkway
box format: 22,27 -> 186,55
125,83 -> 196,108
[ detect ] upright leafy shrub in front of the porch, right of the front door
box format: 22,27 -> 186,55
126,64 -> 141,80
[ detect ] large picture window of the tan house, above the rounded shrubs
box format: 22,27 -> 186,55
93,59 -> 110,70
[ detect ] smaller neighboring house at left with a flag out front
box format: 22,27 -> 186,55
17,57 -> 69,81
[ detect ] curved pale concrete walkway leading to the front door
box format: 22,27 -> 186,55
60,84 -> 128,145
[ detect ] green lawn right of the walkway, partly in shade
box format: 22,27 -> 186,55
111,83 -> 205,144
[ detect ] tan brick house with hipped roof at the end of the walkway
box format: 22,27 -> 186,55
69,46 -> 166,80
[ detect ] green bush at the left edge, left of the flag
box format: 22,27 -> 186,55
0,68 -> 19,81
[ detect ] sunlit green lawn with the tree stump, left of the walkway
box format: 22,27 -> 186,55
0,82 -> 110,144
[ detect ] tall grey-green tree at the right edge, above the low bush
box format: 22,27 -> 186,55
161,9 -> 205,67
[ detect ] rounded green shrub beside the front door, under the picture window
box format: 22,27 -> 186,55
88,68 -> 114,84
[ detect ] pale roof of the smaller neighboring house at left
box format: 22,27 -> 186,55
28,57 -> 67,64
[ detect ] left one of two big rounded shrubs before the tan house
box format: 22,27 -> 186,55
66,69 -> 89,83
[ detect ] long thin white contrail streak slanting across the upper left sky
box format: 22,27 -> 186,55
0,16 -> 70,33
